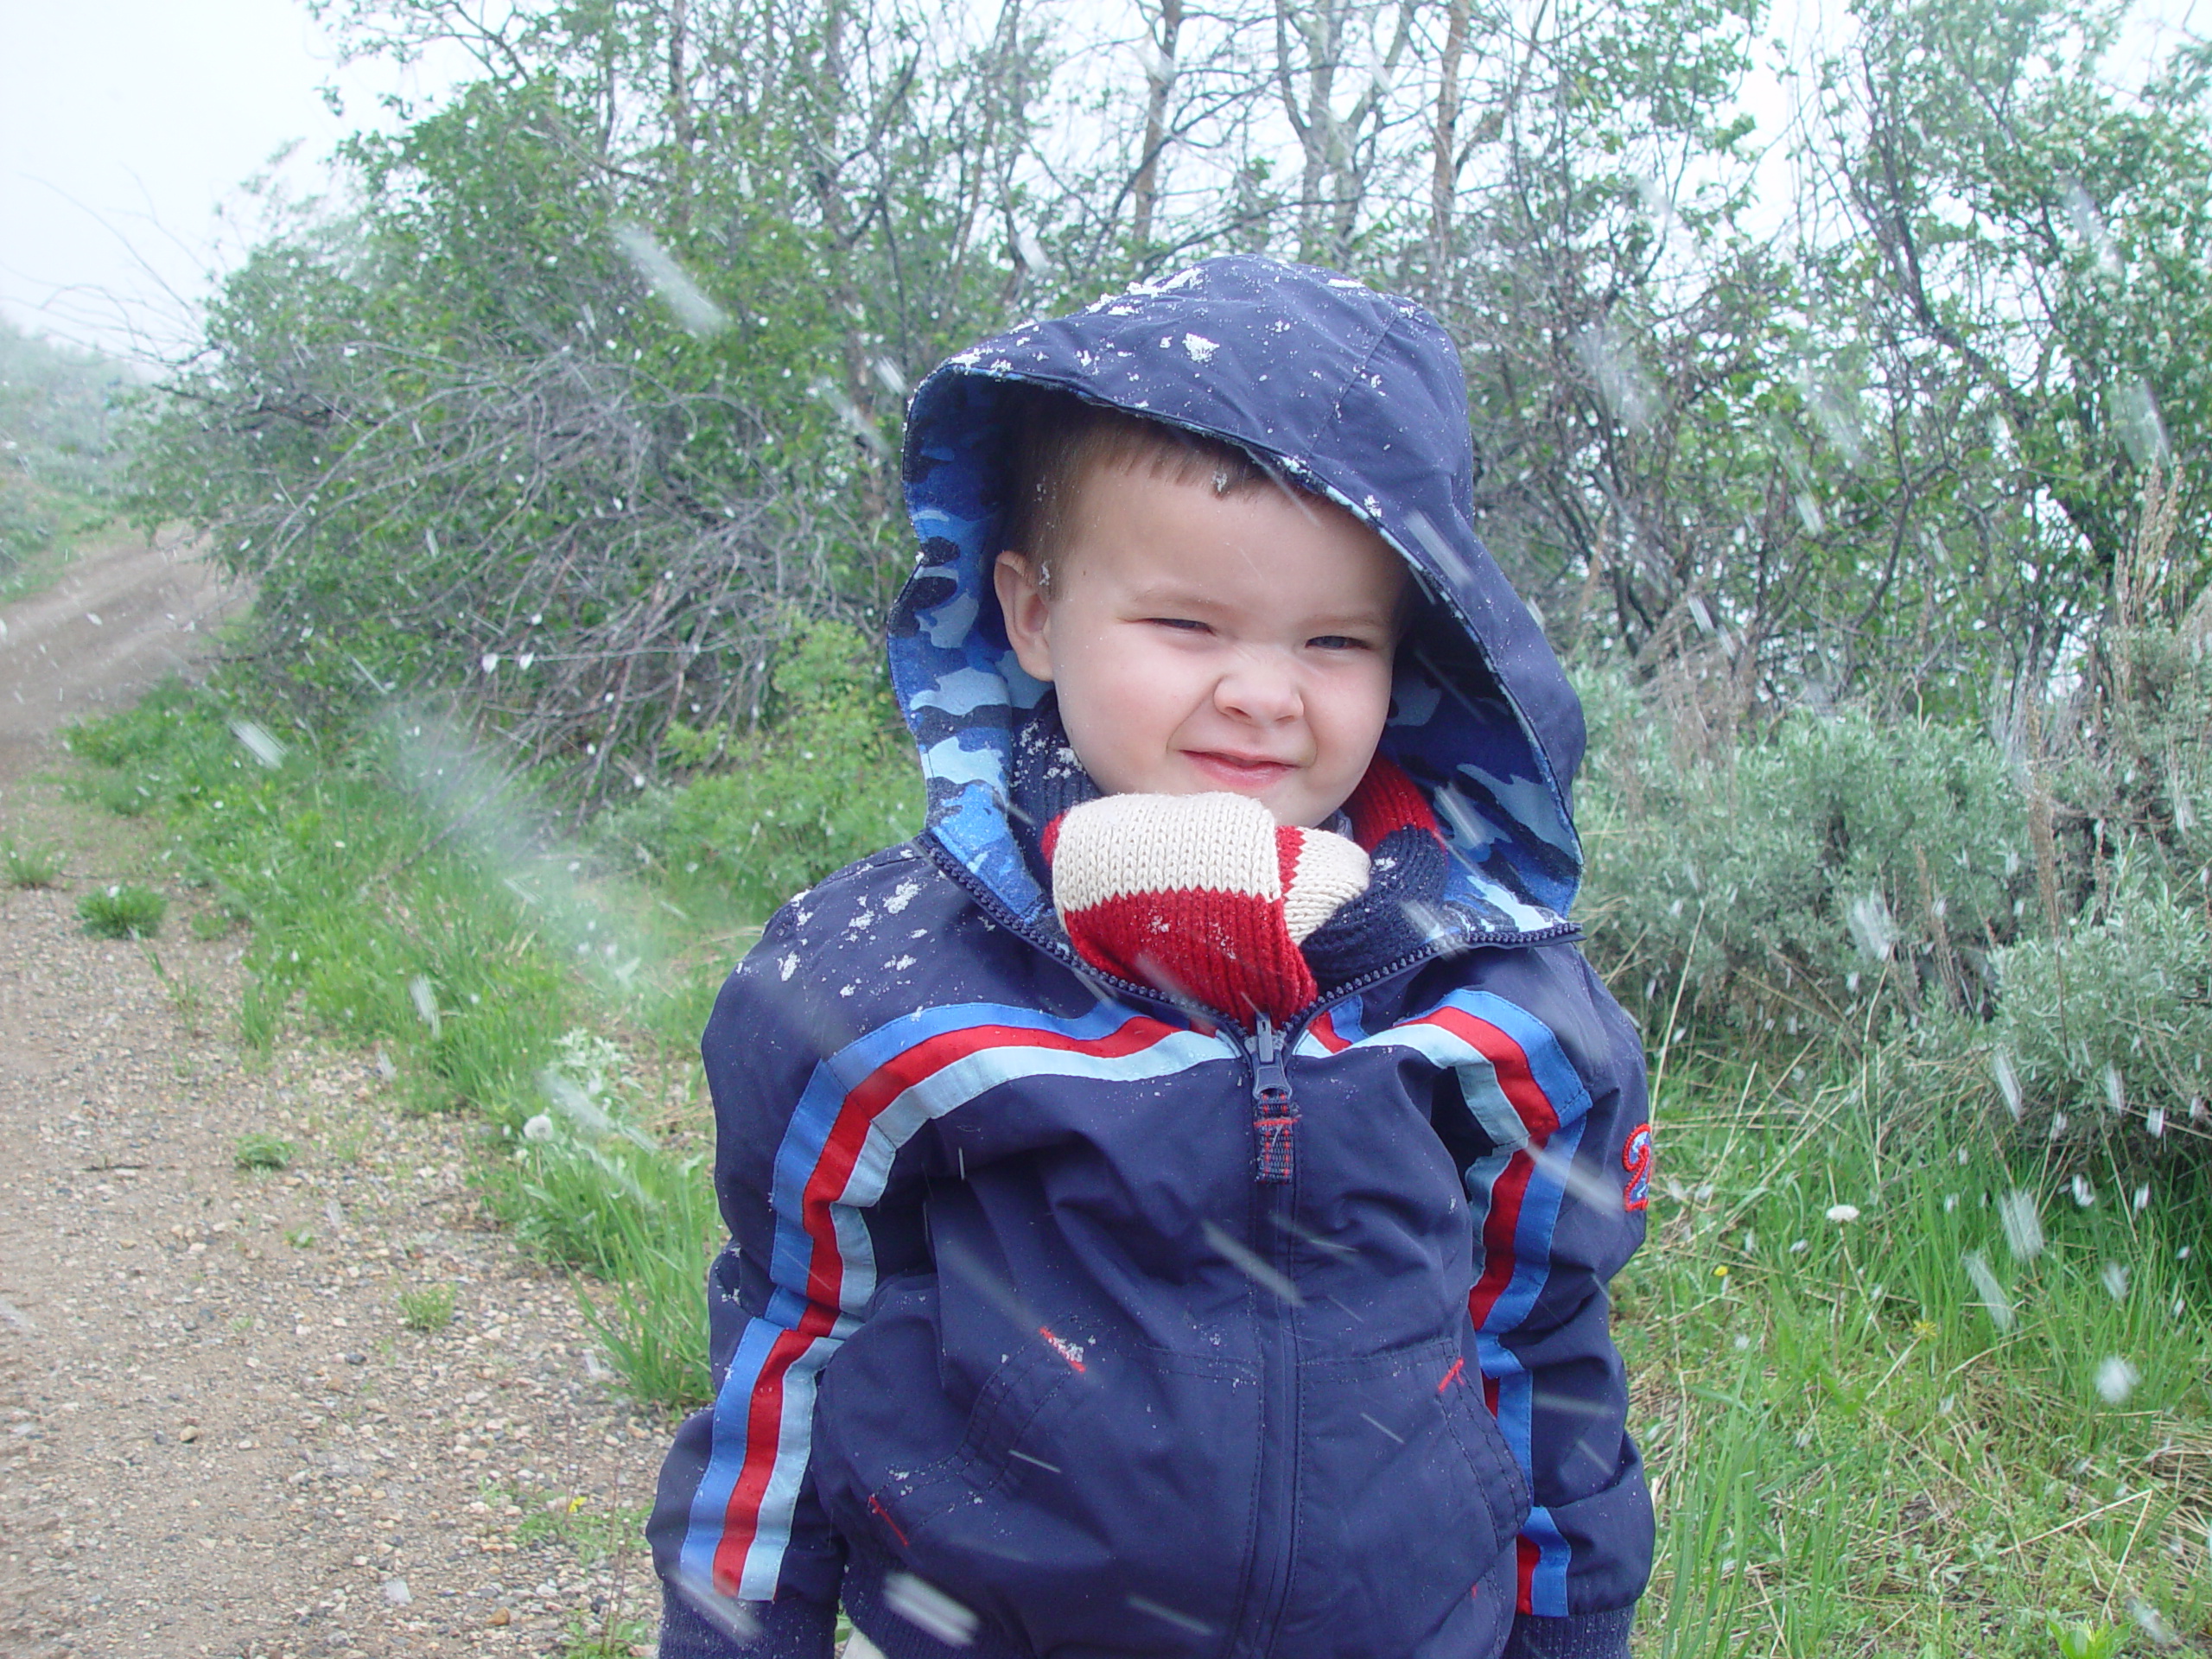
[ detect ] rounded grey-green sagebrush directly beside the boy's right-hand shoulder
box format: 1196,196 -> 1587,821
1577,677 -> 2035,1038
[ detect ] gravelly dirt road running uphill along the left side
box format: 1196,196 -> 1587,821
0,542 -> 664,1659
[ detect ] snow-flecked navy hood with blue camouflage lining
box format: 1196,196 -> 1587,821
889,254 -> 1584,933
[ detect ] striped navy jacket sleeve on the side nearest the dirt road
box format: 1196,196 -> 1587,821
646,907 -> 918,1659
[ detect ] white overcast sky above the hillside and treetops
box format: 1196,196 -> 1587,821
0,0 -> 2212,366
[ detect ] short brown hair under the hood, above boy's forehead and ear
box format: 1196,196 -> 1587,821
998,387 -> 1303,593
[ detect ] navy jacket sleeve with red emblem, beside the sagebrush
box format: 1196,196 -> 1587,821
1462,944 -> 1652,1659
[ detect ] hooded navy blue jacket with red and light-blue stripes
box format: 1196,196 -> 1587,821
648,257 -> 1652,1659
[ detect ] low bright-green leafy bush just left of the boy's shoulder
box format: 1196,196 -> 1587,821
606,621 -> 923,916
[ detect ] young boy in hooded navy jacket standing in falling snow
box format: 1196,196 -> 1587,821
648,257 -> 1652,1659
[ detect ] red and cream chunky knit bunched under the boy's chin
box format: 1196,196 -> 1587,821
1044,794 -> 1370,1020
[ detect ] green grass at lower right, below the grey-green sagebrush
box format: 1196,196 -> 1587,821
1615,1053 -> 2212,1659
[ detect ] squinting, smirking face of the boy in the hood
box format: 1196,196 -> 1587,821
993,467 -> 1405,825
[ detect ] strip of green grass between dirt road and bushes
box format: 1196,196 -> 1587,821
71,686 -> 716,1407
